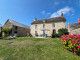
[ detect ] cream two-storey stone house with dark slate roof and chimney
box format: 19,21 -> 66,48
31,13 -> 66,36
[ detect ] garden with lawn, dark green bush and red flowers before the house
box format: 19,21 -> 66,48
0,29 -> 80,60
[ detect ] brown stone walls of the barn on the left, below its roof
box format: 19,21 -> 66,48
3,21 -> 30,36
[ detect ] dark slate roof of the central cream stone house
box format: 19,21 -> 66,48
31,16 -> 66,24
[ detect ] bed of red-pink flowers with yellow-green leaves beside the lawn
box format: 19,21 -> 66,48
61,34 -> 80,55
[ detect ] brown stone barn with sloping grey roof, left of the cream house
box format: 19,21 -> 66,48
3,19 -> 30,36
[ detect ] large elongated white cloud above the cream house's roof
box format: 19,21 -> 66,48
50,7 -> 73,18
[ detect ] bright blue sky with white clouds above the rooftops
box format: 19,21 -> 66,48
0,0 -> 80,26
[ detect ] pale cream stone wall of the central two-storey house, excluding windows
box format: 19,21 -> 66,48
31,22 -> 65,36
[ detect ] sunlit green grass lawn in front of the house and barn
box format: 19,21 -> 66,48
0,37 -> 80,60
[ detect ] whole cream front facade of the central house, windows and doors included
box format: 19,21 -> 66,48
31,17 -> 66,36
